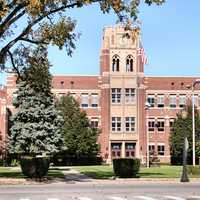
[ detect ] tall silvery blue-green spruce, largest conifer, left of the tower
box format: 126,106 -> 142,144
10,47 -> 64,155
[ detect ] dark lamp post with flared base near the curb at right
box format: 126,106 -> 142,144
180,110 -> 189,182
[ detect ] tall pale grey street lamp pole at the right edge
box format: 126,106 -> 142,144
192,79 -> 200,166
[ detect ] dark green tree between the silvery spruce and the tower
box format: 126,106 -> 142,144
57,94 -> 99,158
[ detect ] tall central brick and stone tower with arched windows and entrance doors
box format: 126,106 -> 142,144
100,26 -> 146,162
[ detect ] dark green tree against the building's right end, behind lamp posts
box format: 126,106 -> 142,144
170,106 -> 200,165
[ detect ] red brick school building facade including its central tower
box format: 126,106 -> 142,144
0,27 -> 200,163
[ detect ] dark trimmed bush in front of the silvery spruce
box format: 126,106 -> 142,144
20,157 -> 49,178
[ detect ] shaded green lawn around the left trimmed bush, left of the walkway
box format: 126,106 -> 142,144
0,167 -> 64,179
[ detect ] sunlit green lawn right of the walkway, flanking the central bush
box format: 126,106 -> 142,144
73,165 -> 200,179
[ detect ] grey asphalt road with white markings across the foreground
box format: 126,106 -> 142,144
0,182 -> 200,200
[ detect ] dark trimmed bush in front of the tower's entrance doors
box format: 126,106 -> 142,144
113,158 -> 140,178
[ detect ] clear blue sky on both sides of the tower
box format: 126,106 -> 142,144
0,0 -> 200,83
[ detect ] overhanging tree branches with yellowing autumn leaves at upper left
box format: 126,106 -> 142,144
0,0 -> 165,75
